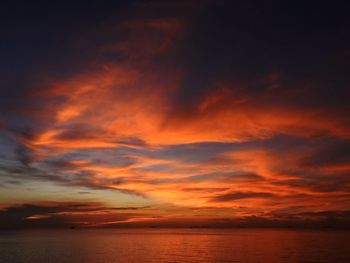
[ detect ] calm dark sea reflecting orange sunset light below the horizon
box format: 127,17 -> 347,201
0,229 -> 350,263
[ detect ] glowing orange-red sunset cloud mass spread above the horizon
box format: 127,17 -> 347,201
3,3 -> 350,226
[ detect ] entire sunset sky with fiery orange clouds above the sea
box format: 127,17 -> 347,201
0,0 -> 350,229
